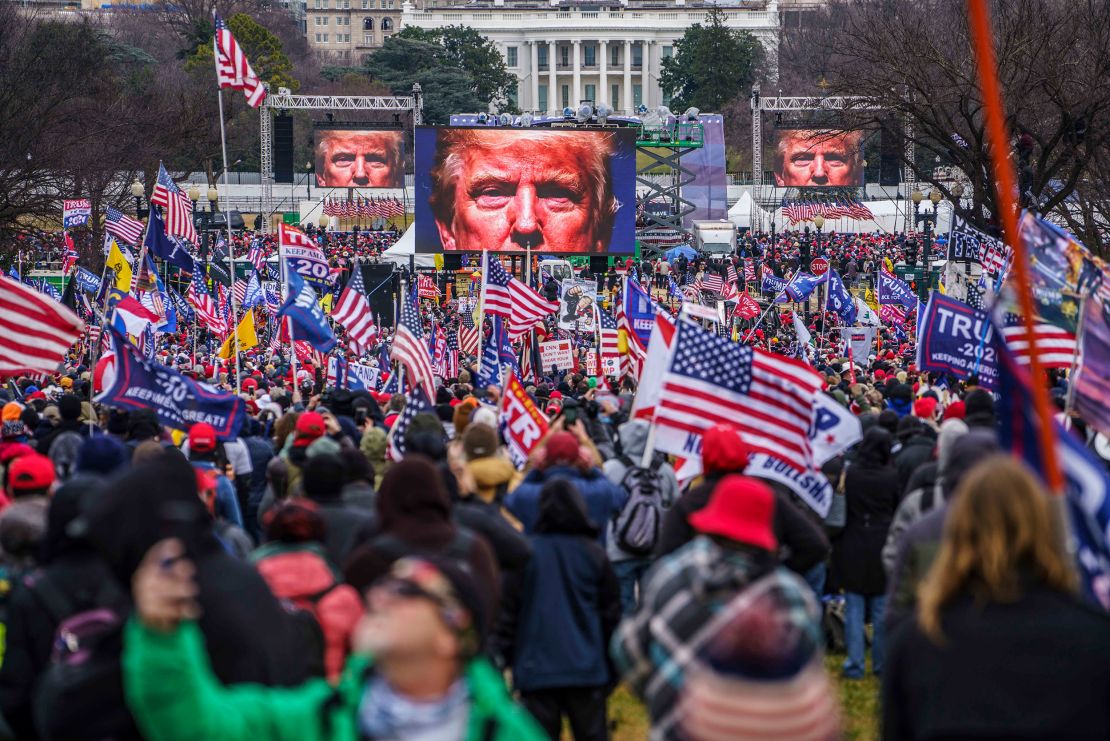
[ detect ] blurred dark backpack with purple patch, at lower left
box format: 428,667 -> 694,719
23,571 -> 139,741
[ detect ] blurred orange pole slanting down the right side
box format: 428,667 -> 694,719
968,0 -> 1063,494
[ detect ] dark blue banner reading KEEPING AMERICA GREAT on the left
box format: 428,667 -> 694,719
97,328 -> 246,439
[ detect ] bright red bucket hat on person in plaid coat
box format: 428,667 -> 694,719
686,474 -> 778,551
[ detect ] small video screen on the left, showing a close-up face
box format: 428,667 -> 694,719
313,125 -> 405,187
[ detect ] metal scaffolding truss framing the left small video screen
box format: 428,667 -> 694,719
259,83 -> 424,232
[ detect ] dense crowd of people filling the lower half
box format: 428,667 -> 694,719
0,221 -> 1110,741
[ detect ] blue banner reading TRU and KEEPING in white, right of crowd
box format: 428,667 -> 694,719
917,291 -> 998,390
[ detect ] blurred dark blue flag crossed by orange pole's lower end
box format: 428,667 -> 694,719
992,332 -> 1110,610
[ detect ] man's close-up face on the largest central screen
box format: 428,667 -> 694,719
430,129 -> 618,253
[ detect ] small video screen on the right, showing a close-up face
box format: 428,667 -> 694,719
775,129 -> 864,187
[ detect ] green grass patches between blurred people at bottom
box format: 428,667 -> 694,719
594,654 -> 879,741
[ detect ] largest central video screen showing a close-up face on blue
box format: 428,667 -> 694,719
415,126 -> 636,255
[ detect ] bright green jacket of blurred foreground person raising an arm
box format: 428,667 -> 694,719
123,620 -> 546,741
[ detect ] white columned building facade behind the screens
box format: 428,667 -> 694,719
401,0 -> 780,113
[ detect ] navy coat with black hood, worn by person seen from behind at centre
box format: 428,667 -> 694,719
498,487 -> 620,692
